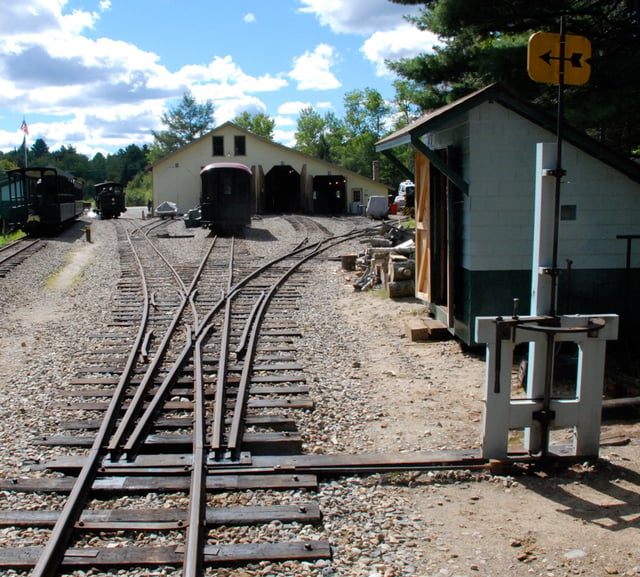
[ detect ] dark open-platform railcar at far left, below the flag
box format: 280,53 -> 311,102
7,166 -> 84,232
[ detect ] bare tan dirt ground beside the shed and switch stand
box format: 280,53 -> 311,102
340,276 -> 640,577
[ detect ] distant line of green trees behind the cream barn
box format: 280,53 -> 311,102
0,88 -> 410,204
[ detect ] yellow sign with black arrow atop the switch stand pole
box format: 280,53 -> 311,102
527,32 -> 591,84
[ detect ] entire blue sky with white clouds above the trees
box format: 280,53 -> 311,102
0,0 -> 436,158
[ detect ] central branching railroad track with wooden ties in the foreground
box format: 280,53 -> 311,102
0,217 -> 368,577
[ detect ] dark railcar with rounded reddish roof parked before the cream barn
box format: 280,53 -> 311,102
200,162 -> 251,234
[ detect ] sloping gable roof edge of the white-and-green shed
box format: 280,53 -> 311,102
376,84 -> 640,182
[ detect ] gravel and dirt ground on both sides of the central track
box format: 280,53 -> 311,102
0,210 -> 640,577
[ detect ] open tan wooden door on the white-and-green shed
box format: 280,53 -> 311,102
415,150 -> 453,326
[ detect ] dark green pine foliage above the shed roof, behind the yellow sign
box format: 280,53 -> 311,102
389,0 -> 640,153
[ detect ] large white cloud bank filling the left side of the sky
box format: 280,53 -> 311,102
0,0 -> 288,156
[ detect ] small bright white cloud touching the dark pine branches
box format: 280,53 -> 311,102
360,24 -> 438,76
